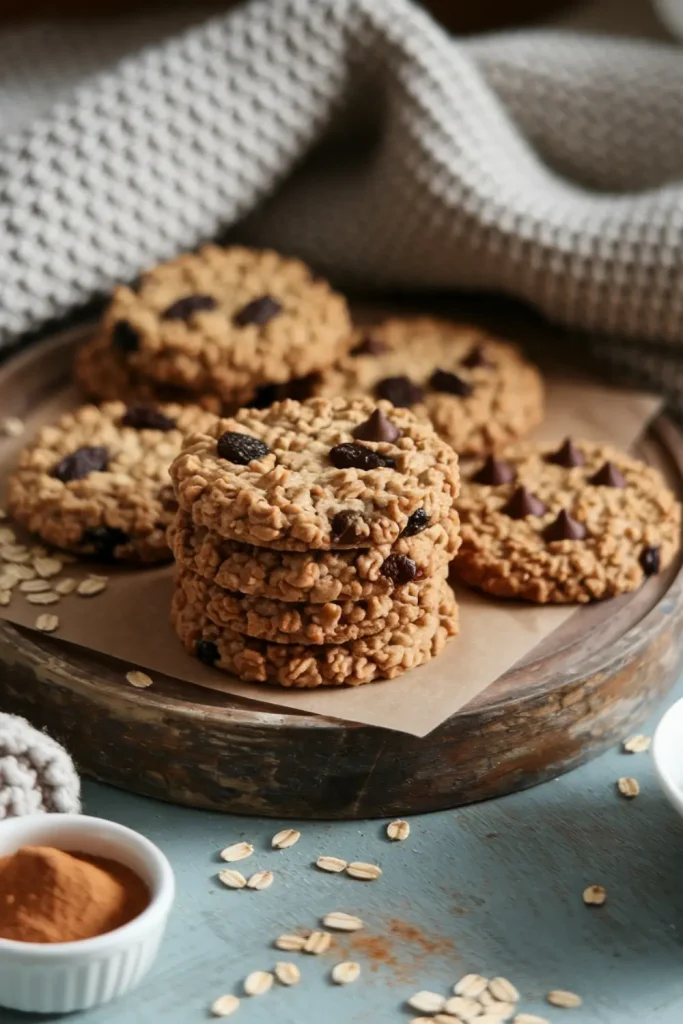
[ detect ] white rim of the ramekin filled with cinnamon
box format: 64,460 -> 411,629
0,814 -> 175,966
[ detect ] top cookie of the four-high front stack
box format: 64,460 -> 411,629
171,398 -> 459,551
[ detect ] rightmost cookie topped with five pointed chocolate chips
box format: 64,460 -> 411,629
455,438 -> 681,603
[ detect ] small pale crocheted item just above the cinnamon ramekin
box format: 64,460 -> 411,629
0,714 -> 81,819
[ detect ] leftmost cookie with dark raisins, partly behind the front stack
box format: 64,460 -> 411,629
8,401 -> 215,563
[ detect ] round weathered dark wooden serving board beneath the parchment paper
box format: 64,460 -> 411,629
0,323 -> 683,818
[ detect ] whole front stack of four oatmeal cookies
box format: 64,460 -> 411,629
171,397 -> 459,687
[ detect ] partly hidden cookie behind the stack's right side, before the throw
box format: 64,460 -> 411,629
315,316 -> 544,455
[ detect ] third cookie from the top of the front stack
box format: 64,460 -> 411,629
176,565 -> 446,644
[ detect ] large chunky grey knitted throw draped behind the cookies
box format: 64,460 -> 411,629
0,0 -> 683,407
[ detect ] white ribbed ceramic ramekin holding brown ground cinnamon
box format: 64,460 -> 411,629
0,814 -> 175,1014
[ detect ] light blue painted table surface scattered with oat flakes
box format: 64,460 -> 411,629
7,684 -> 683,1024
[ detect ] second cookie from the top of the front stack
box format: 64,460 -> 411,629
169,510 -> 460,604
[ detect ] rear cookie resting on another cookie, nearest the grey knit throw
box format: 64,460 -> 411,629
102,246 -> 351,404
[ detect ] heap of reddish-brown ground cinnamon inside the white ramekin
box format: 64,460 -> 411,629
0,846 -> 150,942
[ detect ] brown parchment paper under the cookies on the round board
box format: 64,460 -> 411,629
0,381 -> 659,736
